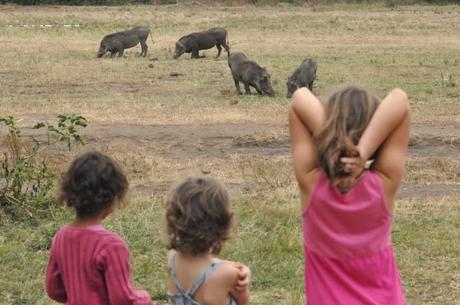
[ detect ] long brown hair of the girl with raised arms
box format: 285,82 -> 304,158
316,86 -> 380,180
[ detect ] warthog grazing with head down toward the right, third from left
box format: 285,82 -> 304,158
228,52 -> 275,96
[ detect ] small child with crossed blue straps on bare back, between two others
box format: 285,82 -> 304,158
166,177 -> 251,305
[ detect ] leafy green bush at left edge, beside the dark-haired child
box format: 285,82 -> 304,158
0,115 -> 87,221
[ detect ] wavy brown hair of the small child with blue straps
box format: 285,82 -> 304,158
166,177 -> 233,255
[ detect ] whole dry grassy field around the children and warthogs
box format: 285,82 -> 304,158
0,4 -> 460,305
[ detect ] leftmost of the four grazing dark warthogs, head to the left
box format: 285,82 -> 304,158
97,26 -> 153,57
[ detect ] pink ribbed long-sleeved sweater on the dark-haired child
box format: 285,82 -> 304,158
46,226 -> 151,305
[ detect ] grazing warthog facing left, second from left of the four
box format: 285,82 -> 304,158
174,28 -> 230,59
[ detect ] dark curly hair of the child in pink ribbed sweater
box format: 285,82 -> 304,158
58,151 -> 128,218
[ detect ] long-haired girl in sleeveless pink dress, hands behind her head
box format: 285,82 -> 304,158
289,87 -> 410,305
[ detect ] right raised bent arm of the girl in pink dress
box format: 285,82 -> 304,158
358,89 -> 410,207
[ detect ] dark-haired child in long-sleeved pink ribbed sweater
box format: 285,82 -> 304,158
46,152 -> 151,305
